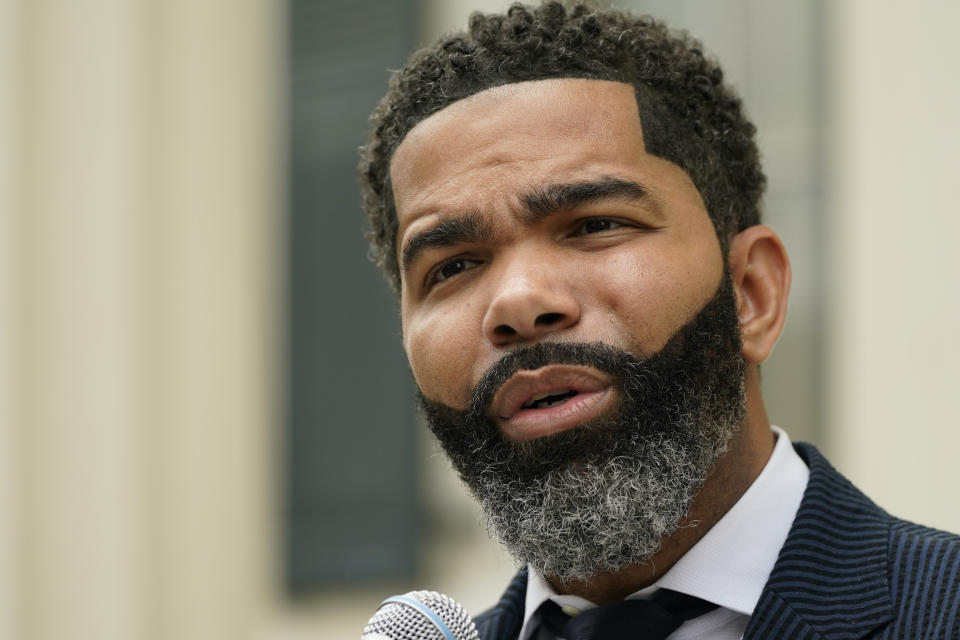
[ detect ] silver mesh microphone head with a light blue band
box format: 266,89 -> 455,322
360,591 -> 480,640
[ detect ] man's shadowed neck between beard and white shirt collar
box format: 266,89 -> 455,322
547,366 -> 774,605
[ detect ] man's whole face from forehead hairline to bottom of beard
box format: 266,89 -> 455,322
391,80 -> 744,579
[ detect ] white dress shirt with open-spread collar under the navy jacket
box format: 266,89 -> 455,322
519,427 -> 810,640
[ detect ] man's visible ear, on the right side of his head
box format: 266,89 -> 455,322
729,224 -> 790,364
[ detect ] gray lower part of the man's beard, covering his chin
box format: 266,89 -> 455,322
474,409 -> 739,580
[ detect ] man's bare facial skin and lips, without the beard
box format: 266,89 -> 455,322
391,79 -> 723,422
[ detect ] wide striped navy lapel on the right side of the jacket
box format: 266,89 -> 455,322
744,444 -> 893,640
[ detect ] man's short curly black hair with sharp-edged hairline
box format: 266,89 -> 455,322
359,2 -> 766,292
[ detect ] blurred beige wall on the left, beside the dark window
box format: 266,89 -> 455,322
0,0 -> 282,640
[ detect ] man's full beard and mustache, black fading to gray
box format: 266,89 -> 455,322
418,272 -> 745,580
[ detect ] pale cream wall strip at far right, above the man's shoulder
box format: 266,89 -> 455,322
824,0 -> 960,531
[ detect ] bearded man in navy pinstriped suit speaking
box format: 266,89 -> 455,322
361,3 -> 960,640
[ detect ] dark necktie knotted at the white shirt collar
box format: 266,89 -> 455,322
540,589 -> 717,640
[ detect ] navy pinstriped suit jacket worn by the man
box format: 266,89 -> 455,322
475,443 -> 960,640
